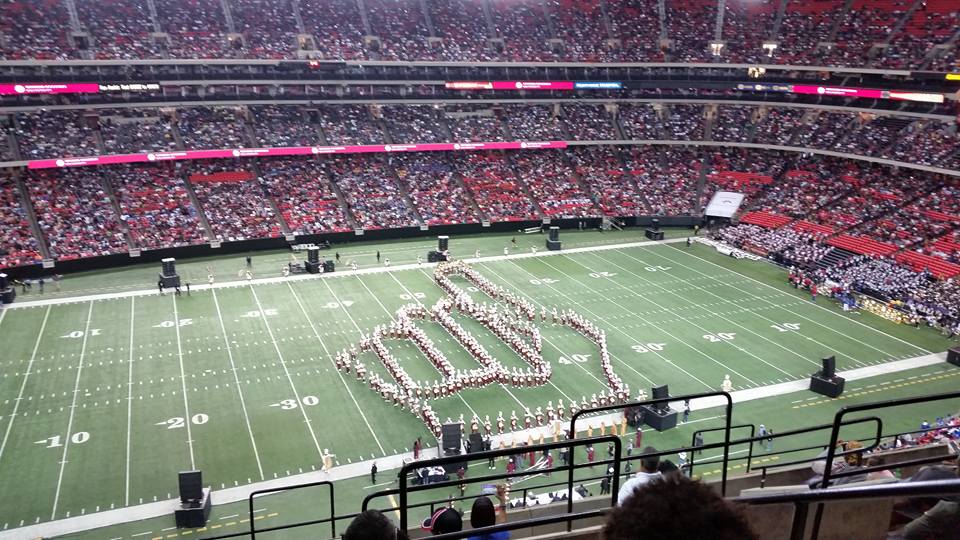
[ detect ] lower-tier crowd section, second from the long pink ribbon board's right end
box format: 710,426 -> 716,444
456,152 -> 539,221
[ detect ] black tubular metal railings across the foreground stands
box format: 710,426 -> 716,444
197,391 -> 960,540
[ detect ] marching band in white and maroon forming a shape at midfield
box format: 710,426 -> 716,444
334,261 -> 630,436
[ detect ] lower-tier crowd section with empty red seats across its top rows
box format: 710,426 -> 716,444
187,161 -> 282,242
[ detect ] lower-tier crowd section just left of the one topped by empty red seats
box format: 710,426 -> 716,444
113,164 -> 206,249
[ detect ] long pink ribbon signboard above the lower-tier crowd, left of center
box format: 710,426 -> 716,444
27,141 -> 567,169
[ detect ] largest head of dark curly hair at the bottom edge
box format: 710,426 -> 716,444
603,476 -> 757,540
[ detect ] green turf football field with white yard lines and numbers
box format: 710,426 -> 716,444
0,233 -> 960,538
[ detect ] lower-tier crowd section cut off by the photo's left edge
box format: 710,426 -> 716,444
0,171 -> 42,268
